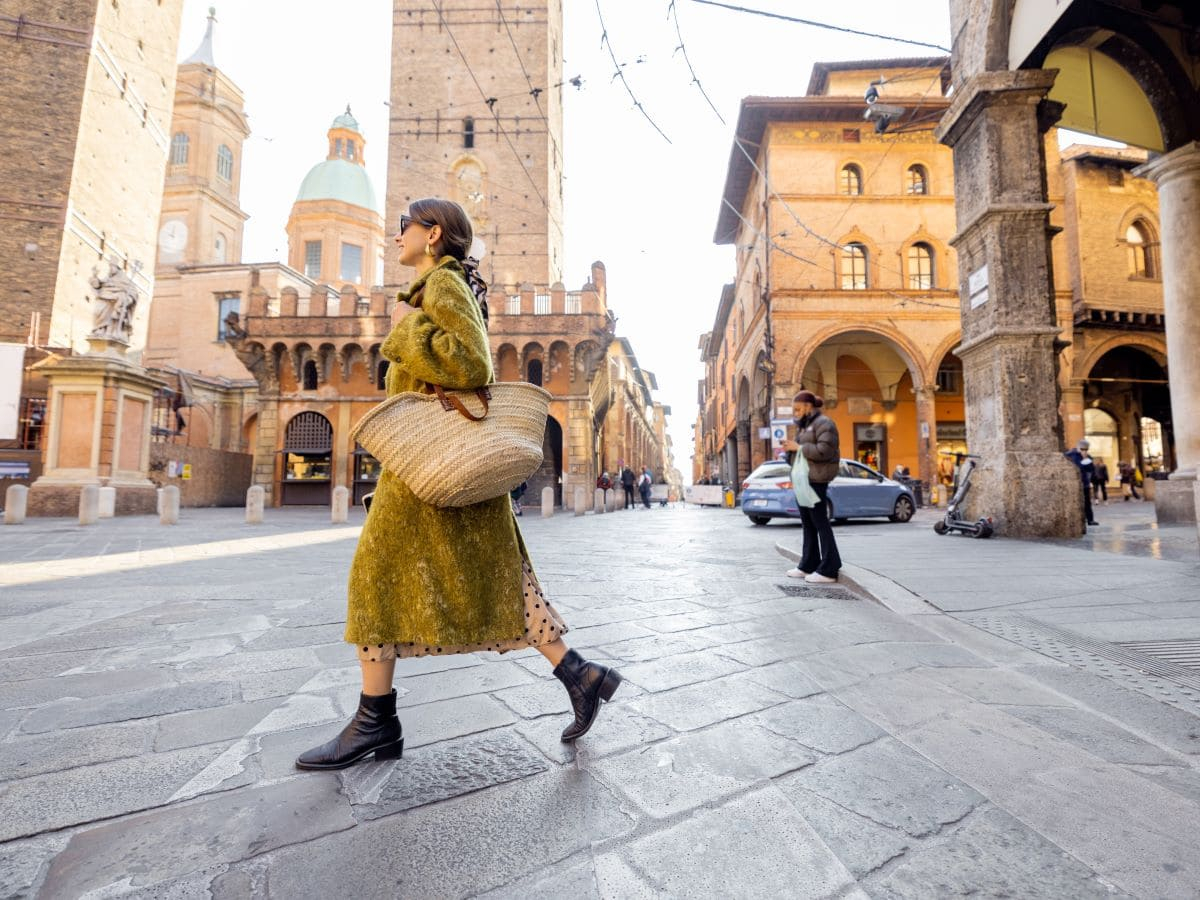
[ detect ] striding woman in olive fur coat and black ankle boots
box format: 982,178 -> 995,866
296,199 -> 620,769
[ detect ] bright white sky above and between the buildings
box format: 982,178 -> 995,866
179,0 -> 950,480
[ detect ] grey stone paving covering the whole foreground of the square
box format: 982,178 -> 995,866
0,504 -> 1200,899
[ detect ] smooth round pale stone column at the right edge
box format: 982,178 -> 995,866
1134,140 -> 1200,523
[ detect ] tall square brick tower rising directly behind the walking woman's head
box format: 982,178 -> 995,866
384,0 -> 563,287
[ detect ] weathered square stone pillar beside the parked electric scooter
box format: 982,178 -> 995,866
936,70 -> 1084,538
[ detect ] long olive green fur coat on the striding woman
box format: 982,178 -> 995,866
346,257 -> 527,652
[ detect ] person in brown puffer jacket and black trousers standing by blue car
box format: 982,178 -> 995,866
784,391 -> 841,584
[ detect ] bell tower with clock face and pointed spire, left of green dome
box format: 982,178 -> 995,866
157,8 -> 250,271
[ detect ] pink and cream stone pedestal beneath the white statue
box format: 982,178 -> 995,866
29,338 -> 166,516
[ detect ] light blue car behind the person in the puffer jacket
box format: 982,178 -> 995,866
742,460 -> 917,524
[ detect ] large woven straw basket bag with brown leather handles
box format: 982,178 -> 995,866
350,382 -> 551,506
